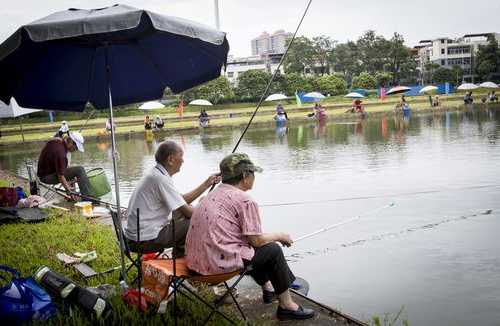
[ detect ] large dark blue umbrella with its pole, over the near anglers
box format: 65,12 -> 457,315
0,5 -> 229,280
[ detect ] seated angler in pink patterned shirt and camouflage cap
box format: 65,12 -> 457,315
186,153 -> 314,320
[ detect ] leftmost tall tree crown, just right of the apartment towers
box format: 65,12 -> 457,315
283,36 -> 316,74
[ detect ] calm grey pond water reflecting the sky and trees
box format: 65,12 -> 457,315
0,107 -> 500,325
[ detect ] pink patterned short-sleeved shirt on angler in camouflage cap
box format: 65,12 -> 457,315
186,184 -> 262,275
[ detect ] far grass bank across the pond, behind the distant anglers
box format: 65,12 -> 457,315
0,96 -> 468,145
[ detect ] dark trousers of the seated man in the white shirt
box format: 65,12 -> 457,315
126,211 -> 190,257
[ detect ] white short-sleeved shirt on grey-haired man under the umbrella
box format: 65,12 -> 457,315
125,164 -> 186,241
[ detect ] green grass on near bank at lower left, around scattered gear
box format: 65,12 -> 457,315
0,210 -> 238,325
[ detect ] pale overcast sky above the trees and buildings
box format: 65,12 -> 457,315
0,0 -> 500,56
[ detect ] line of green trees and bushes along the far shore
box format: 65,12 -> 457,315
173,30 -> 500,104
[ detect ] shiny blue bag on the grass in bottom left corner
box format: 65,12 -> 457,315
0,265 -> 57,325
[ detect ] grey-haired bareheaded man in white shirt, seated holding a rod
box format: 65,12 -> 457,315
125,141 -> 220,257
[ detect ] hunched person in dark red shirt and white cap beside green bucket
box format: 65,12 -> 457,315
37,132 -> 91,201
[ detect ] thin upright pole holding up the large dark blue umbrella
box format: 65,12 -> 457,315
106,46 -> 127,283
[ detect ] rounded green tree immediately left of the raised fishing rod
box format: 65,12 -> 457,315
234,69 -> 271,101
